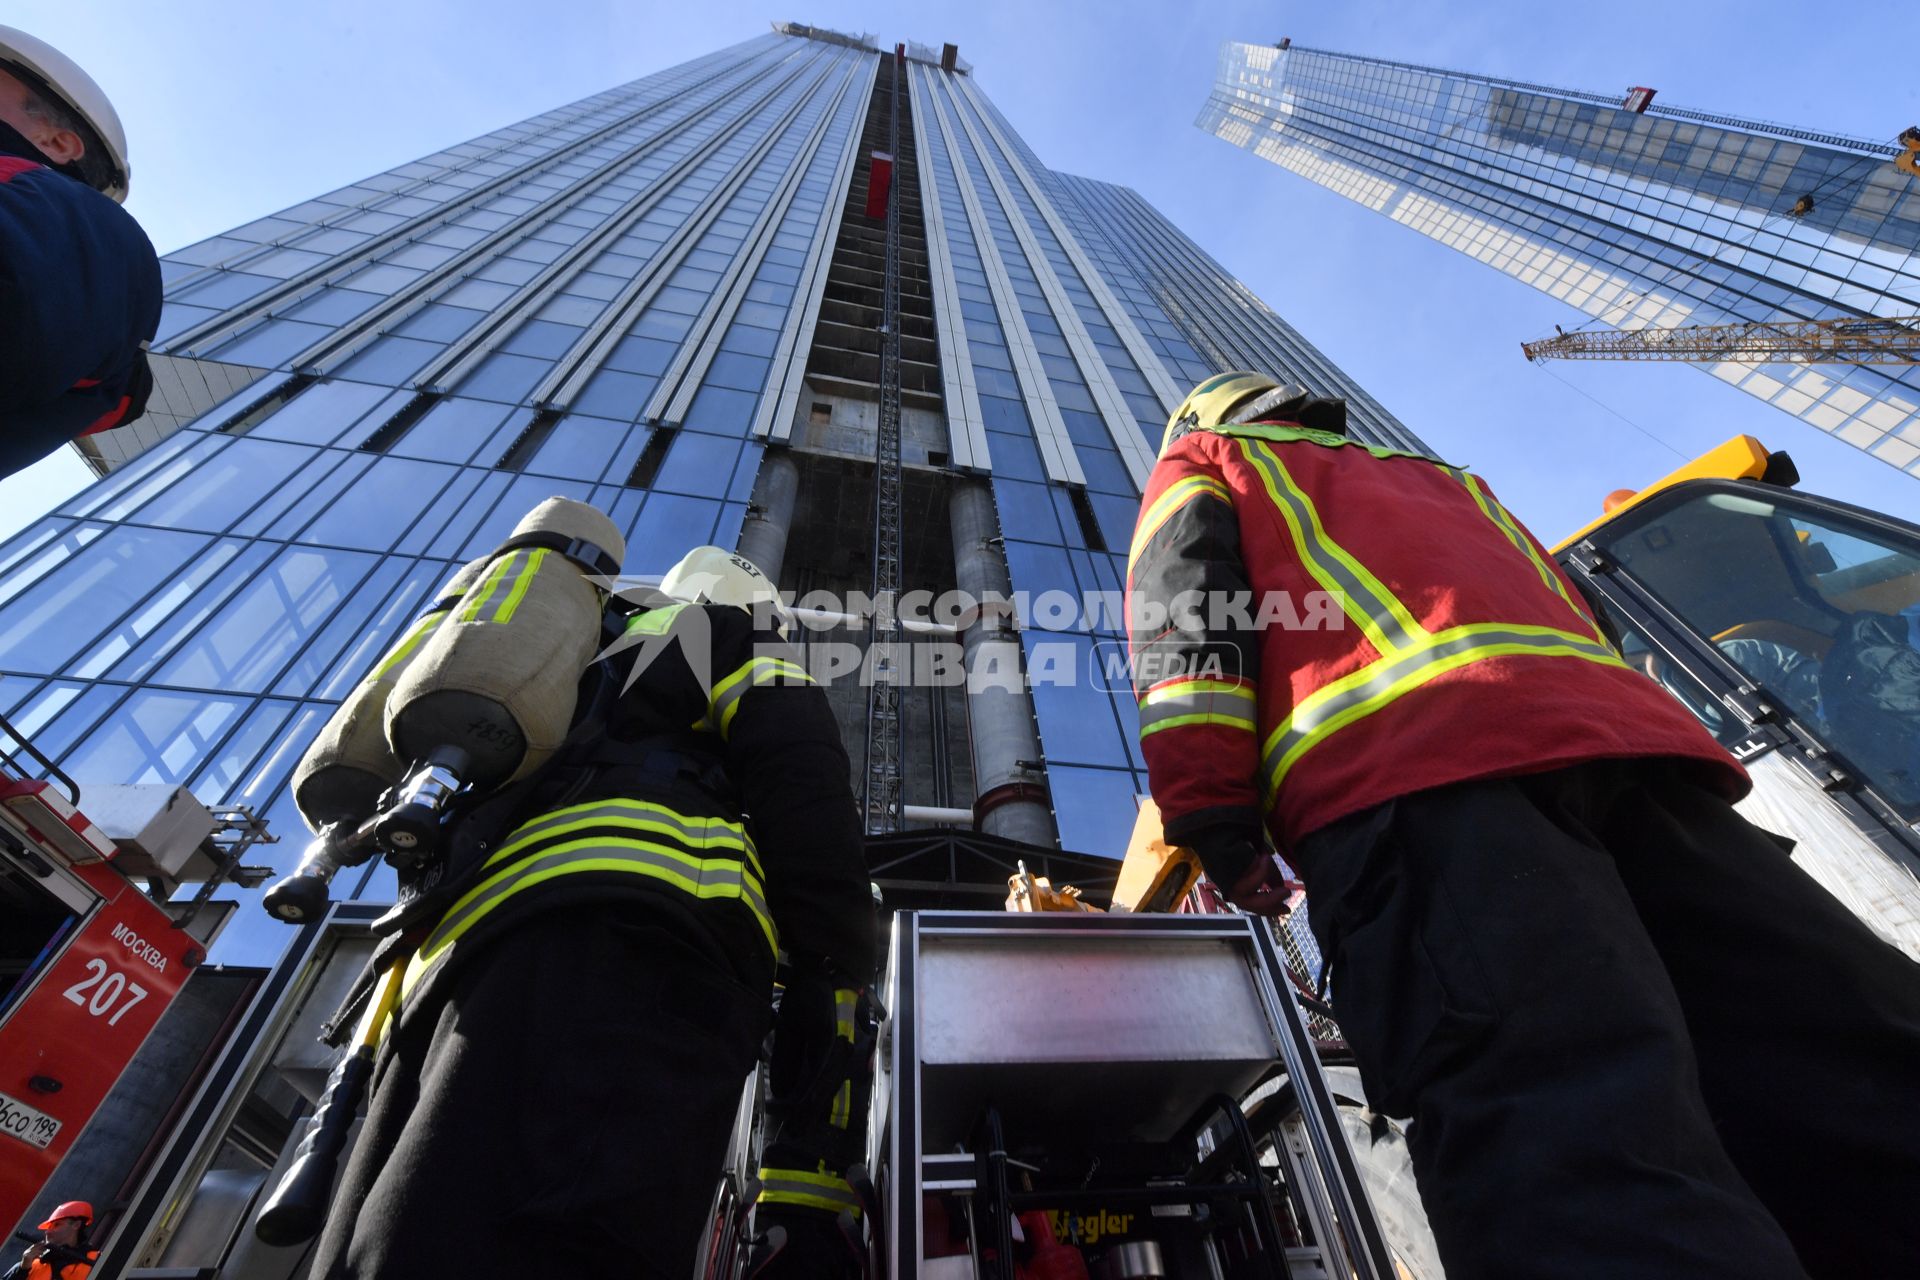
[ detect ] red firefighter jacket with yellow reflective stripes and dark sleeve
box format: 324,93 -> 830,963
1127,424 -> 1747,854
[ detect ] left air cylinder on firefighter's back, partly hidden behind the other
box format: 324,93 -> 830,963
294,557 -> 492,833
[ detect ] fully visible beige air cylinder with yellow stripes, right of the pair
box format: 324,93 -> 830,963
378,497 -> 626,860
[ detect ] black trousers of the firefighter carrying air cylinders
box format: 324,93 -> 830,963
309,906 -> 770,1280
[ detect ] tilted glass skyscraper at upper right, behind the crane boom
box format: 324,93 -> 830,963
1196,42 -> 1920,476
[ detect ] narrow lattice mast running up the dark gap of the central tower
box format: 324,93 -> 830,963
864,52 -> 906,835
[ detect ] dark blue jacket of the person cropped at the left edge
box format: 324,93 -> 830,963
0,123 -> 161,476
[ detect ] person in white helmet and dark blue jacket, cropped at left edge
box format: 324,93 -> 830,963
0,27 -> 161,476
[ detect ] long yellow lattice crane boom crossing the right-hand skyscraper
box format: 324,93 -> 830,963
1521,315 -> 1920,365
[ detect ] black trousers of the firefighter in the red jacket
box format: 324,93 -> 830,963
1294,760 -> 1920,1280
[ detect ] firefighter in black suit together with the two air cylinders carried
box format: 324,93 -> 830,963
257,499 -> 874,1280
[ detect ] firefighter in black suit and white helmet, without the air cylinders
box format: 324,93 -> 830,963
311,547 -> 874,1280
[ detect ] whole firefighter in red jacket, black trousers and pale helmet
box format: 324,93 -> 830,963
1127,372 -> 1920,1280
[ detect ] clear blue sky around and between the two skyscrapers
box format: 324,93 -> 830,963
0,0 -> 1920,541
